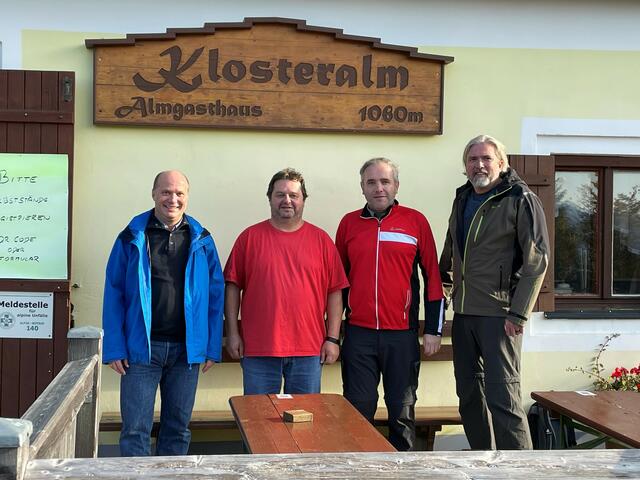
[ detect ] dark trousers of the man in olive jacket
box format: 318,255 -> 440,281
451,313 -> 531,450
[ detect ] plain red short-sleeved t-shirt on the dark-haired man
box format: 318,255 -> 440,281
224,220 -> 349,357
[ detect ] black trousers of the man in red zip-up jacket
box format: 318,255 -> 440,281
341,324 -> 420,451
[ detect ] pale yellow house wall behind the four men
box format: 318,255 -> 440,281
22,31 -> 640,411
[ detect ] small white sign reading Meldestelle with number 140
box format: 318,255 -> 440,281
0,292 -> 53,338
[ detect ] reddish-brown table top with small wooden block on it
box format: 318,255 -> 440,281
229,393 -> 395,453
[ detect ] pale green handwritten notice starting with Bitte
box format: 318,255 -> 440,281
0,153 -> 69,280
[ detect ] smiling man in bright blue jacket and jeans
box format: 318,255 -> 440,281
102,171 -> 224,456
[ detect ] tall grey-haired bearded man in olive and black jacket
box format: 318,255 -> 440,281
440,135 -> 549,450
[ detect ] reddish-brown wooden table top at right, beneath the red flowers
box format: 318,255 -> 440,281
531,391 -> 640,448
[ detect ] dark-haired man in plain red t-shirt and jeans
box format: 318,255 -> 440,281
224,168 -> 349,395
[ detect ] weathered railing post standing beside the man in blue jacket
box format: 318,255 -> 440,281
67,327 -> 102,458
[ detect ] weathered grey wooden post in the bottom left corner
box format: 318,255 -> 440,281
0,418 -> 33,480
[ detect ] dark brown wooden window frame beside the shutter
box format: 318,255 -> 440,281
554,154 -> 640,311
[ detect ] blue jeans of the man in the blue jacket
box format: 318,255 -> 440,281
120,341 -> 198,457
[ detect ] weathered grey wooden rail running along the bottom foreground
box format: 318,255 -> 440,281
26,449 -> 640,480
